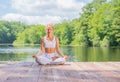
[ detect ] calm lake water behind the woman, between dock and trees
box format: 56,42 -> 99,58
0,45 -> 120,62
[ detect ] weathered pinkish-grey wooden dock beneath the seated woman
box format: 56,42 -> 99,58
0,62 -> 120,82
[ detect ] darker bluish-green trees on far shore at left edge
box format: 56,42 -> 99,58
0,21 -> 28,44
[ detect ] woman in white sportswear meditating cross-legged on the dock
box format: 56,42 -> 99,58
33,24 -> 68,64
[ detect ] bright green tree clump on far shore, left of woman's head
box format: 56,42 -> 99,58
14,25 -> 45,45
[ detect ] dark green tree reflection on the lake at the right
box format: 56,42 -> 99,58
70,46 -> 120,61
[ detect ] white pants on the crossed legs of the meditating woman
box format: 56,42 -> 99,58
36,53 -> 66,65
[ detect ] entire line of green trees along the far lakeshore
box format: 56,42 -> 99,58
0,0 -> 120,46
